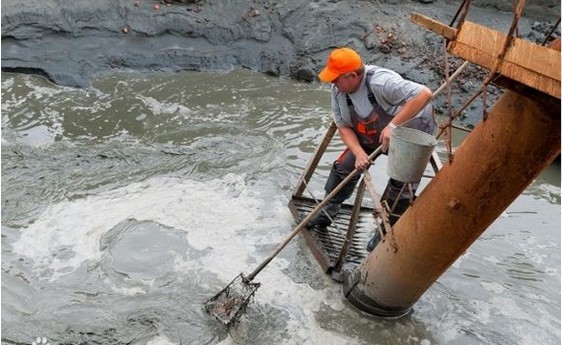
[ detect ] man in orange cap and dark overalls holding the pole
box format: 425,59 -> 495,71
307,47 -> 436,251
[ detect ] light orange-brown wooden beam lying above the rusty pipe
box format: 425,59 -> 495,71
412,13 -> 561,100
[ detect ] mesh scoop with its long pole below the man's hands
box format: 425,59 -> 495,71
205,146 -> 382,326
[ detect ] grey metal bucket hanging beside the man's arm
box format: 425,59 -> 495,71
387,127 -> 437,183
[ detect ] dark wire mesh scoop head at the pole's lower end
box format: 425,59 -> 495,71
205,273 -> 261,326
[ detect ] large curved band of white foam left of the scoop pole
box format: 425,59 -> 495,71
13,173 -> 284,279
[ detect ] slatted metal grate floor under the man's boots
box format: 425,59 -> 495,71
289,196 -> 376,273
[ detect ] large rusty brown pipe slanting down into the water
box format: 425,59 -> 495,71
344,79 -> 560,317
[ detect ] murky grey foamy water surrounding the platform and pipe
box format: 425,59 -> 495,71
2,71 -> 560,345
